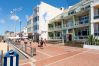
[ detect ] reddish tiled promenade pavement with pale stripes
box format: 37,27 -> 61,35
16,40 -> 99,66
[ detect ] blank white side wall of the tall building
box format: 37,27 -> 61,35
39,2 -> 63,39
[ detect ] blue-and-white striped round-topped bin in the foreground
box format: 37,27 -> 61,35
4,50 -> 19,66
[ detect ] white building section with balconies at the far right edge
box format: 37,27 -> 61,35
91,0 -> 99,38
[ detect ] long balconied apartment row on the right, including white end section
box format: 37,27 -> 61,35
48,0 -> 99,41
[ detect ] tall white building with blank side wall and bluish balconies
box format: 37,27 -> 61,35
27,2 -> 63,40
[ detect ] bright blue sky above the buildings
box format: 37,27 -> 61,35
0,0 -> 79,34
